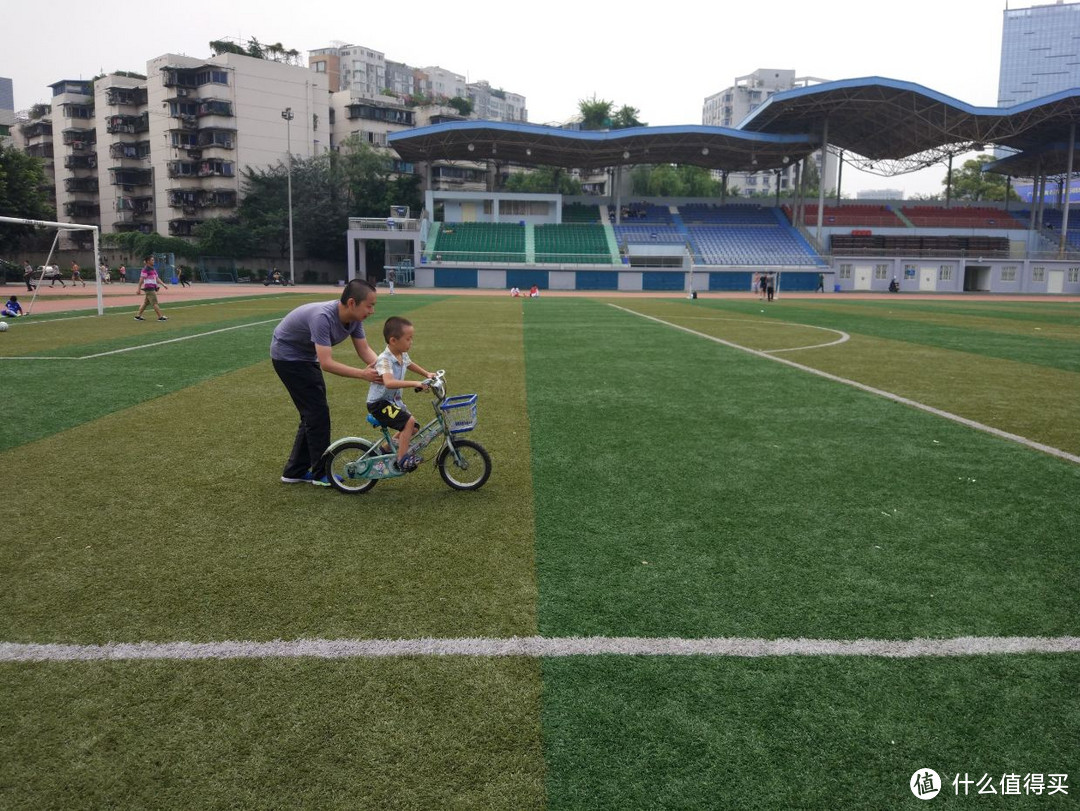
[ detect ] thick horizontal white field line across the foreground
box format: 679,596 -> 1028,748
0,636 -> 1080,662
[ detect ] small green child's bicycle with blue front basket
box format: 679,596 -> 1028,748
324,369 -> 491,492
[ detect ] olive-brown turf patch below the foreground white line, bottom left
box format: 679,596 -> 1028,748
0,659 -> 544,810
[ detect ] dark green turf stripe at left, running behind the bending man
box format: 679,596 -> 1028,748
0,296 -> 428,450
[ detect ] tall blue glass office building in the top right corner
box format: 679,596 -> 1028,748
998,0 -> 1080,107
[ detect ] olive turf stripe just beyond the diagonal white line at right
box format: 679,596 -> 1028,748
623,301 -> 1080,462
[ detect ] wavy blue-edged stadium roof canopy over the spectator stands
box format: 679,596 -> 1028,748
389,77 -> 1080,175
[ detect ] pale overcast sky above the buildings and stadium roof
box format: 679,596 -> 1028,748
0,0 -> 1010,194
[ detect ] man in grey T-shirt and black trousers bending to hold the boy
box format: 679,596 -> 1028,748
270,279 -> 381,487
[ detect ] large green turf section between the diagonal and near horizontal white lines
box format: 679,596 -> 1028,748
526,300 -> 1080,638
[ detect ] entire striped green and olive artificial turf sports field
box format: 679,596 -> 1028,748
0,295 -> 1080,809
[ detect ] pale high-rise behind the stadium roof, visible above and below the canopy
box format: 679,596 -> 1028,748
701,68 -> 837,195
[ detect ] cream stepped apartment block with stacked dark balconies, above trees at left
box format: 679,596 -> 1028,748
39,53 -> 332,242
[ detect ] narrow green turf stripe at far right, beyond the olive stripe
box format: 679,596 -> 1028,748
704,300 -> 1080,371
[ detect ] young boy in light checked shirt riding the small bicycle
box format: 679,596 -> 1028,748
367,315 -> 431,473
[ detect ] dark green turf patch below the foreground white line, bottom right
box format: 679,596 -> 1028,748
543,655 -> 1080,811
